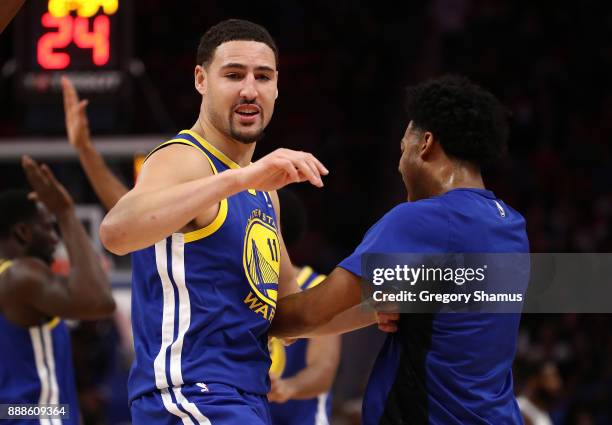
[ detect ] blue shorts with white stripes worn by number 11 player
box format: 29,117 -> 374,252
131,383 -> 272,425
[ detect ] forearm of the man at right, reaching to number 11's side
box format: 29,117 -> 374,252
270,267 -> 361,337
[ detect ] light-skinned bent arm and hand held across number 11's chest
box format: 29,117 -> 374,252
100,145 -> 327,255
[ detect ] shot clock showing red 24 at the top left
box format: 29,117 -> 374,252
15,0 -> 132,132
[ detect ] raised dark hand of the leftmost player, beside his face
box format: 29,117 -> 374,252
21,156 -> 74,216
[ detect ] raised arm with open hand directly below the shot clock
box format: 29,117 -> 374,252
62,77 -> 128,210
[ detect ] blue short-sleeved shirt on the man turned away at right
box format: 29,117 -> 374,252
339,189 -> 529,425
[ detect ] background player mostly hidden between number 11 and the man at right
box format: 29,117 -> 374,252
268,188 -> 341,425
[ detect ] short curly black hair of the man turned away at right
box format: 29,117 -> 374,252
406,75 -> 508,166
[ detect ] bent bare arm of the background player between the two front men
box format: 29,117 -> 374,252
268,336 -> 341,403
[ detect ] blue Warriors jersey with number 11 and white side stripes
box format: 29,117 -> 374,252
128,130 -> 280,410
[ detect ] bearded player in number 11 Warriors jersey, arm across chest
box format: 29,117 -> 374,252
100,20 -> 327,425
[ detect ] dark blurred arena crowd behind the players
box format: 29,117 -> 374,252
0,0 -> 612,424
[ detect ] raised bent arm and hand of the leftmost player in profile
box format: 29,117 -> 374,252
15,157 -> 115,319
